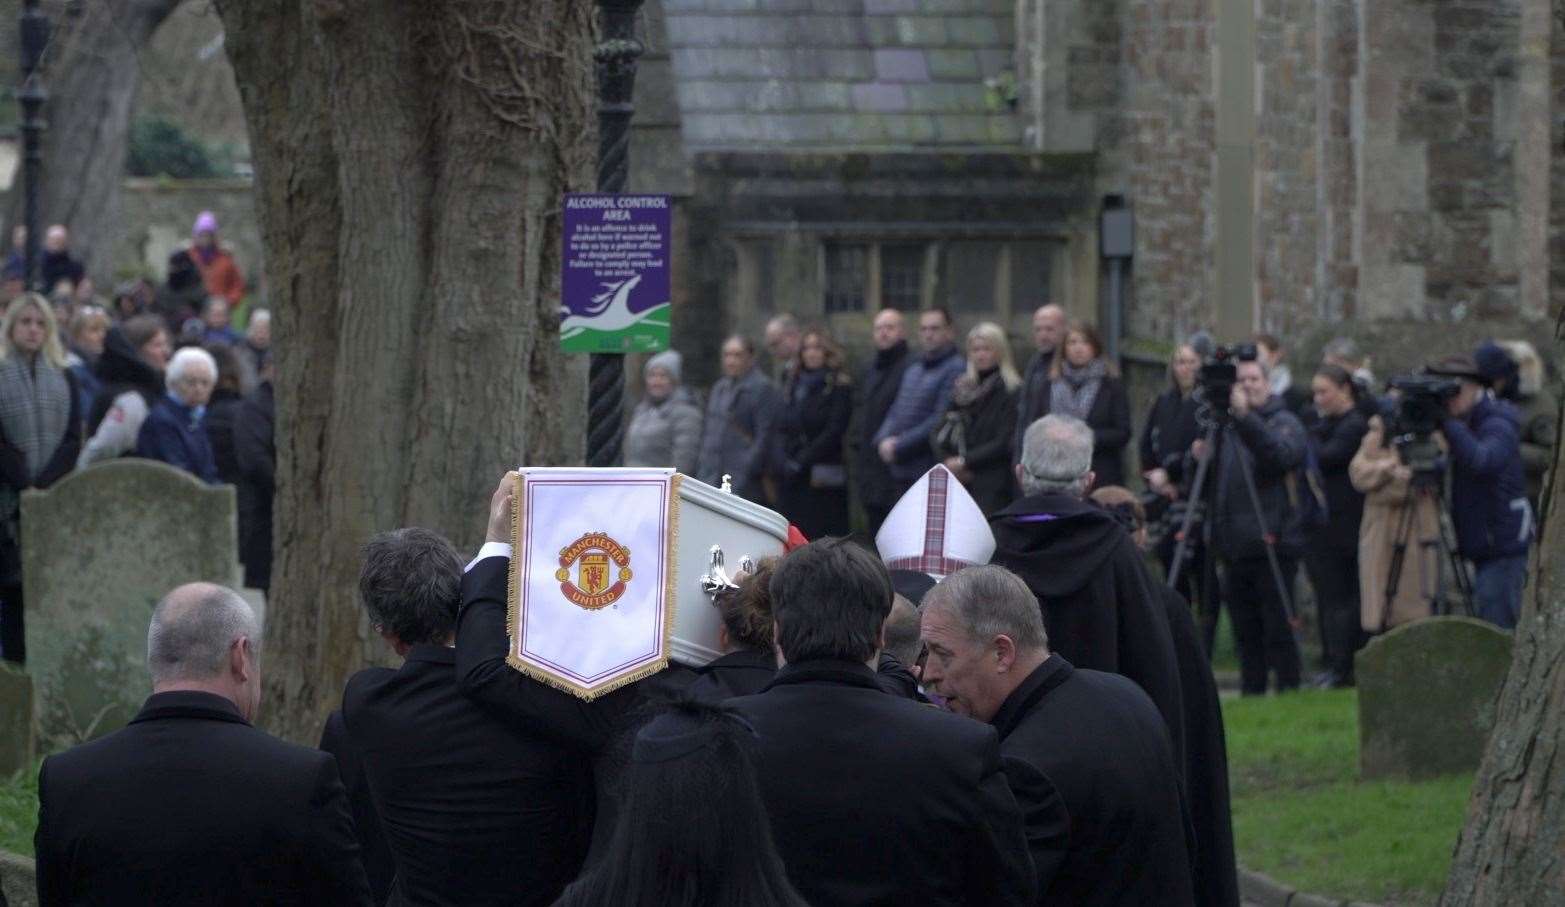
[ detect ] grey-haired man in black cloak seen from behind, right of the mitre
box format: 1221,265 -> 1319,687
989,416 -> 1183,751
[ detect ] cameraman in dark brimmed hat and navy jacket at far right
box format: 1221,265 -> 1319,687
1426,357 -> 1534,629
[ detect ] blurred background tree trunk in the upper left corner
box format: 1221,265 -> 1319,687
9,0 -> 180,279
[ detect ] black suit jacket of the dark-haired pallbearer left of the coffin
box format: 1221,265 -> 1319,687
343,646 -> 592,905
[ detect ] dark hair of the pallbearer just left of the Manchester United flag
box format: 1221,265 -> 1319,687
358,527 -> 462,646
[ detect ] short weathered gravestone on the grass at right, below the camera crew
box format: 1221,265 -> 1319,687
1354,618 -> 1512,780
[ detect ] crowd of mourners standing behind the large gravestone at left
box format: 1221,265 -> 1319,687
0,211 -> 275,661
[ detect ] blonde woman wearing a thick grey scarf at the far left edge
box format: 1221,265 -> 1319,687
0,294 -> 81,663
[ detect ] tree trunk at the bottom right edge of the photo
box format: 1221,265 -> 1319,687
1440,328 -> 1565,907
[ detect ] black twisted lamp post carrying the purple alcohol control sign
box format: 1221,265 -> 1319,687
587,0 -> 642,466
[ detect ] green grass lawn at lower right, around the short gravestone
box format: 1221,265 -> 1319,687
1222,690 -> 1473,904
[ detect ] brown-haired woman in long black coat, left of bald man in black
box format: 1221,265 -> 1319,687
773,328 -> 853,540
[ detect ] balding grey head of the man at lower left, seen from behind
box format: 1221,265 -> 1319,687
147,583 -> 261,691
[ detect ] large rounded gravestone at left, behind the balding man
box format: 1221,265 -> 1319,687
22,460 -> 239,752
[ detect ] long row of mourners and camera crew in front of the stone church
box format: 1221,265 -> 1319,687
624,305 -> 1539,693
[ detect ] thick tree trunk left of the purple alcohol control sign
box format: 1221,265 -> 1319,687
218,0 -> 593,743
